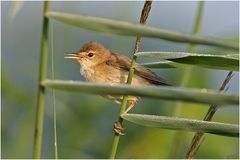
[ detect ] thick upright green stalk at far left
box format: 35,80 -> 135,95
33,1 -> 49,159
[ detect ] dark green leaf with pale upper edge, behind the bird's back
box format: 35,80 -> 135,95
138,52 -> 239,71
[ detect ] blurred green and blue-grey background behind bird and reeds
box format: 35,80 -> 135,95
1,1 -> 239,158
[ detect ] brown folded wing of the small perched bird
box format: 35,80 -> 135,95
106,53 -> 170,86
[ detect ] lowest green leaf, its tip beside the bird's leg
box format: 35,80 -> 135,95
121,114 -> 239,137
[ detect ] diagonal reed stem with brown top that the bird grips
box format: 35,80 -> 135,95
110,0 -> 152,159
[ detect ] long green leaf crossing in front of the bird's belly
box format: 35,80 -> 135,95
42,80 -> 239,105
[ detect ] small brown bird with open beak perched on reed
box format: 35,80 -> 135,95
65,42 -> 169,113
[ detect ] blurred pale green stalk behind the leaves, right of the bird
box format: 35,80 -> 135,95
169,1 -> 204,158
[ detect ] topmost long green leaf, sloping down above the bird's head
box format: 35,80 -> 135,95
46,12 -> 239,50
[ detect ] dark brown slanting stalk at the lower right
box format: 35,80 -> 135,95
185,71 -> 233,159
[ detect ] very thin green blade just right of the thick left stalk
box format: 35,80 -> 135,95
51,21 -> 58,159
